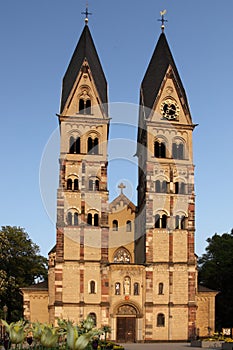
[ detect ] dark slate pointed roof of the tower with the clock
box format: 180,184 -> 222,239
140,32 -> 188,114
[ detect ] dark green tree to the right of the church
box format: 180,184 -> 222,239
198,230 -> 233,330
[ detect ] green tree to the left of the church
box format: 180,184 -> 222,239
0,226 -> 47,321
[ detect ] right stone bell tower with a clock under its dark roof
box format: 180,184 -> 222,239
135,28 -> 197,340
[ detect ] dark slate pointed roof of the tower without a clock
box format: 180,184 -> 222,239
60,24 -> 108,113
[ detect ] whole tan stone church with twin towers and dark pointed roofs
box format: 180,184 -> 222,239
22,21 -> 216,342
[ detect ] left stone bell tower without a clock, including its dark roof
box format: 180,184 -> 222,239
49,20 -> 109,322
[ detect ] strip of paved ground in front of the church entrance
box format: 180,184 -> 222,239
121,343 -> 220,350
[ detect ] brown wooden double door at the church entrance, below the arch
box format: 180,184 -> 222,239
117,317 -> 136,343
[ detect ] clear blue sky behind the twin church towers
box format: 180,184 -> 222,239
0,0 -> 233,255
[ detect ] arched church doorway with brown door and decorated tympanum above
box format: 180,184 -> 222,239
116,305 -> 137,343
